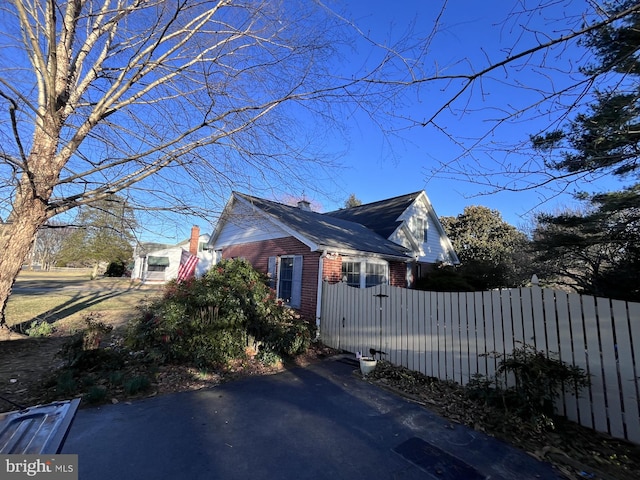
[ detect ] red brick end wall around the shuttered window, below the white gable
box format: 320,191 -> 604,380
222,237 -> 320,324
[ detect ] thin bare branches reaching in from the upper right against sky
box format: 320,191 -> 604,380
416,0 -> 640,199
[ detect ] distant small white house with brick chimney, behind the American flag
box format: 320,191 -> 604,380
131,225 -> 213,283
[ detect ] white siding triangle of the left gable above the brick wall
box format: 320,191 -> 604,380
211,202 -> 290,250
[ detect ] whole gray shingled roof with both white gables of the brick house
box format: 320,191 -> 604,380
210,190 -> 459,264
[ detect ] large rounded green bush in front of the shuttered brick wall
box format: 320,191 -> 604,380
127,259 -> 311,368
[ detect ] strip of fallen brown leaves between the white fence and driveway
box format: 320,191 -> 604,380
367,361 -> 640,480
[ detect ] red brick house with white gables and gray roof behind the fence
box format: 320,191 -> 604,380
209,191 -> 459,330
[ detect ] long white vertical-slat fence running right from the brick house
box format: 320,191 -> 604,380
320,282 -> 640,443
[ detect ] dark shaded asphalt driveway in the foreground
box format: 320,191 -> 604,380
62,357 -> 562,480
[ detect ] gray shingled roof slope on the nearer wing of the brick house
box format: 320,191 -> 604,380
235,192 -> 410,258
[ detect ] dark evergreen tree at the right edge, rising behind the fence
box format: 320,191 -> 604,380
532,1 -> 640,299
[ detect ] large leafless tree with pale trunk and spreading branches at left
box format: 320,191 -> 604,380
0,0 -> 430,325
